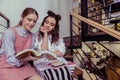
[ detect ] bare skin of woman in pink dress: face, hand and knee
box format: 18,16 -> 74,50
21,14 -> 44,80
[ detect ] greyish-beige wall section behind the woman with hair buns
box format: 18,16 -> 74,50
47,0 -> 73,37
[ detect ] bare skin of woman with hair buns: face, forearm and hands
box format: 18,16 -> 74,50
40,17 -> 63,57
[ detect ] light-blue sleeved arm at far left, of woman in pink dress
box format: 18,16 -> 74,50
2,29 -> 22,67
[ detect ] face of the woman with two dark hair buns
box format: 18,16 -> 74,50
43,17 -> 56,32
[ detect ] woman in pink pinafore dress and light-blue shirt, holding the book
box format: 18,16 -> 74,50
0,8 -> 43,80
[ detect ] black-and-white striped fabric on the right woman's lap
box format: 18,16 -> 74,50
44,66 -> 73,80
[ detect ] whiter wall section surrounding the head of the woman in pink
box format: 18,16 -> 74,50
0,0 -> 47,32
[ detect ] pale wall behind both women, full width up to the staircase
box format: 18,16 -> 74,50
0,0 -> 72,37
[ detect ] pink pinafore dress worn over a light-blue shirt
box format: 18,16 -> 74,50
0,29 -> 36,80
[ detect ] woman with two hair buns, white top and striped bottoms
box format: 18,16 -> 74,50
34,10 -> 72,80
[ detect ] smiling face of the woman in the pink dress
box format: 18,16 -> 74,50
21,13 -> 38,31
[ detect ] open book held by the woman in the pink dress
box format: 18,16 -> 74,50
16,49 -> 57,59
